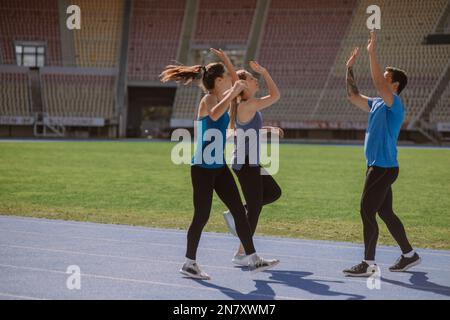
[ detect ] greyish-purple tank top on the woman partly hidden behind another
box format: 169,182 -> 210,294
231,111 -> 263,170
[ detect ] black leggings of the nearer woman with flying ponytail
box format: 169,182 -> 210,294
186,165 -> 255,260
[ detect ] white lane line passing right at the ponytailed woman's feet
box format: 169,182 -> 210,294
0,244 -> 450,291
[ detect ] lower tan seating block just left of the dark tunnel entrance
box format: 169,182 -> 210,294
41,74 -> 116,119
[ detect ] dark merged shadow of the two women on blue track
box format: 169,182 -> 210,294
190,270 -> 365,300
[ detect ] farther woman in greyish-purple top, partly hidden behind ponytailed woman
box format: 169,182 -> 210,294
224,61 -> 283,265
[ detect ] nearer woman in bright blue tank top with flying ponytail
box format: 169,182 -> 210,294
160,49 -> 278,280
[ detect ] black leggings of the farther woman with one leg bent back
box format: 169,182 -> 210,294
234,164 -> 281,235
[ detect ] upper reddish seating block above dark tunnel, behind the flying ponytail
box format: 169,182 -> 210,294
128,0 -> 186,81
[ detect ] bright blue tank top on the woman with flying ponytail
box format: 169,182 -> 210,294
191,112 -> 230,169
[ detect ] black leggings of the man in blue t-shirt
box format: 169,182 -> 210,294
361,167 -> 412,260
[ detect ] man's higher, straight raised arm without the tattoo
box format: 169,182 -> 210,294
367,31 -> 394,107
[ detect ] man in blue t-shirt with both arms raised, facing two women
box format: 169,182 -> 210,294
344,31 -> 421,277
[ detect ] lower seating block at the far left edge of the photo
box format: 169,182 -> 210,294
0,72 -> 31,117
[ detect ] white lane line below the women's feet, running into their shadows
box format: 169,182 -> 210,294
0,264 -> 303,300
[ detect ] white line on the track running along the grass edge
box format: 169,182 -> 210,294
0,215 -> 450,257
